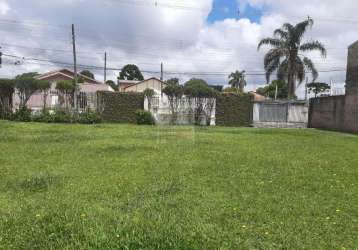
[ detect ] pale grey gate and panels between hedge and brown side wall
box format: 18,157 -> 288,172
253,101 -> 308,128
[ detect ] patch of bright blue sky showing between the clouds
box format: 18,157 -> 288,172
207,0 -> 262,23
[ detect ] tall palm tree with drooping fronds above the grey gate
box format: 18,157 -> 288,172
258,18 -> 327,99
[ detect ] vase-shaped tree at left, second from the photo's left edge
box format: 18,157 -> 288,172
15,72 -> 42,109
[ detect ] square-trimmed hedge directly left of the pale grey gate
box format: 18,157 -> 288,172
216,93 -> 253,127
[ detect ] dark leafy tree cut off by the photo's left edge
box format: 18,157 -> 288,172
0,79 -> 15,118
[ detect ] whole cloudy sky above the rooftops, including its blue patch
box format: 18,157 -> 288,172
0,0 -> 358,96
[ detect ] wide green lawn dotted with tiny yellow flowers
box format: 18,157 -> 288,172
0,122 -> 358,250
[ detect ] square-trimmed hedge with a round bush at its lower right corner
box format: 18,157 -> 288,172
97,91 -> 144,123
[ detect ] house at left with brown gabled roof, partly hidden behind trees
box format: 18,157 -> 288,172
14,69 -> 114,110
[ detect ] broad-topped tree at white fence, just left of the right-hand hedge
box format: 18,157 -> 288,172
184,78 -> 217,125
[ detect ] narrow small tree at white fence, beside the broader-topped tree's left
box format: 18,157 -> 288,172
163,83 -> 184,124
